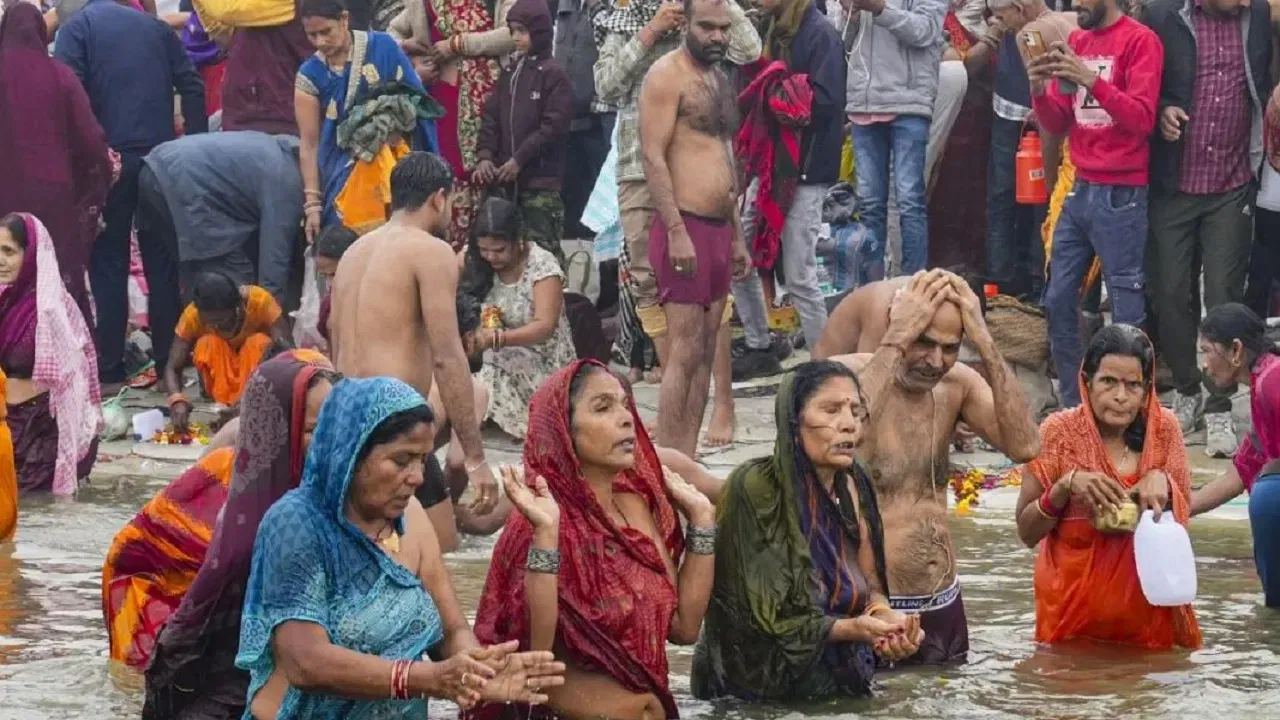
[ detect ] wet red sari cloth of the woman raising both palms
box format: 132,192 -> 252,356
475,360 -> 685,719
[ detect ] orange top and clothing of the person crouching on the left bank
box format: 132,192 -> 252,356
174,286 -> 284,405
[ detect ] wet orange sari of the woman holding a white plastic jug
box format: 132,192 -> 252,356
1025,379 -> 1202,648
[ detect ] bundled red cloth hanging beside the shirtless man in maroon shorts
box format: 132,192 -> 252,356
733,60 -> 813,269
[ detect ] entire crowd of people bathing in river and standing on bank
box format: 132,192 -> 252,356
0,0 -> 1280,719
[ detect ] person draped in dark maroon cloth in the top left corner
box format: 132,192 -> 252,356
0,3 -> 113,316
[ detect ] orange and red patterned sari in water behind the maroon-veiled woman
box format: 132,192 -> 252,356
102,447 -> 236,670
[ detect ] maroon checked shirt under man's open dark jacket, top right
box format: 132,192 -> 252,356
1178,0 -> 1253,195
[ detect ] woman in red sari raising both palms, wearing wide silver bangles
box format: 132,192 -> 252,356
475,360 -> 716,720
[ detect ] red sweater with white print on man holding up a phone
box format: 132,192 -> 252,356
1032,17 -> 1165,187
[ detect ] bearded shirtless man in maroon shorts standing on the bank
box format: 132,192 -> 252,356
639,0 -> 751,457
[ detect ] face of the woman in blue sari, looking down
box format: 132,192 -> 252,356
349,423 -> 435,520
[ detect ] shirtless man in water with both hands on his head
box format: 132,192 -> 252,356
832,270 -> 1039,665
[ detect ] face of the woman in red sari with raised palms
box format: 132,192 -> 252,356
571,370 -> 636,471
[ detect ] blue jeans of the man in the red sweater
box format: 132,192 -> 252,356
1044,179 -> 1147,407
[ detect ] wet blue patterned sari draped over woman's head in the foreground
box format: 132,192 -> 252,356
236,378 -> 444,720
